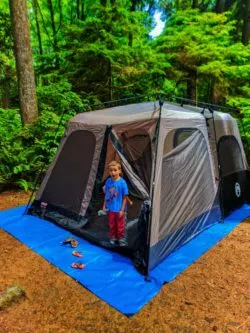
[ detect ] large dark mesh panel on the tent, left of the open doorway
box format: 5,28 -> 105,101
41,131 -> 96,213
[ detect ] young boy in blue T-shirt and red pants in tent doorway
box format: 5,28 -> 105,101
103,161 -> 128,246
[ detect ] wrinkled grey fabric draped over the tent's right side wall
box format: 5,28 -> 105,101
159,131 -> 216,239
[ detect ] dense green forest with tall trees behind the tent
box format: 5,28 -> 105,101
0,0 -> 250,191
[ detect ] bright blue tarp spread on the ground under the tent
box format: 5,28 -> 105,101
0,205 -> 250,316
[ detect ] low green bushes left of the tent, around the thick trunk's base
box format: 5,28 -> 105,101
0,109 -> 69,190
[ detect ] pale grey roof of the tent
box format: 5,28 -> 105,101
70,101 -> 231,125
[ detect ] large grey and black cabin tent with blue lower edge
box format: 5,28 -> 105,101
29,102 -> 250,274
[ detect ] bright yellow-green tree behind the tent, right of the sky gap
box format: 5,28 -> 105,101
156,10 -> 237,103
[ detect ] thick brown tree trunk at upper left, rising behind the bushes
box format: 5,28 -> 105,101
9,0 -> 38,124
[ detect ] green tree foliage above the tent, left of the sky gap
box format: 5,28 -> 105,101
62,4 -> 164,101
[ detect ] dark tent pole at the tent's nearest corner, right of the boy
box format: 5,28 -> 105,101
145,98 -> 164,281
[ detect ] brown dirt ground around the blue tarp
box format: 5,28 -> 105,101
0,192 -> 250,333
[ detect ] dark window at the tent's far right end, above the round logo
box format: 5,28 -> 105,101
218,136 -> 244,177
